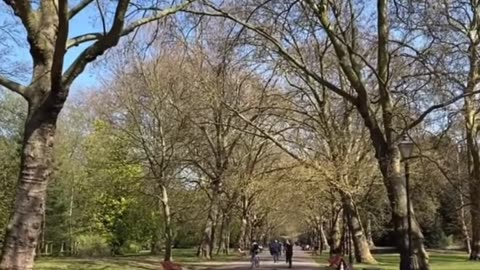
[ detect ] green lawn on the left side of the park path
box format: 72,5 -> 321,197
34,249 -> 240,270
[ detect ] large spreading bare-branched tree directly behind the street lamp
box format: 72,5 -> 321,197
190,0 -> 475,270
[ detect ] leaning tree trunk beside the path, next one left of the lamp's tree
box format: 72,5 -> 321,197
342,194 -> 377,264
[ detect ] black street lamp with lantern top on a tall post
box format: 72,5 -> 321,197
398,136 -> 414,270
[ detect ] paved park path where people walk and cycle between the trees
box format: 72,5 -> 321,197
187,248 -> 324,270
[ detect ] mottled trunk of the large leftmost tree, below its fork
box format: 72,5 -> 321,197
0,97 -> 64,270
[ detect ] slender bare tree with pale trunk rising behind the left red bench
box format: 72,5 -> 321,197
99,47 -> 192,261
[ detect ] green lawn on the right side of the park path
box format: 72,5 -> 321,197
315,252 -> 480,270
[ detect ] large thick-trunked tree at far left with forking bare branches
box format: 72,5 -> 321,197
0,0 -> 195,269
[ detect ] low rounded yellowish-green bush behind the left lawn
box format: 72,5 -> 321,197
75,234 -> 110,257
